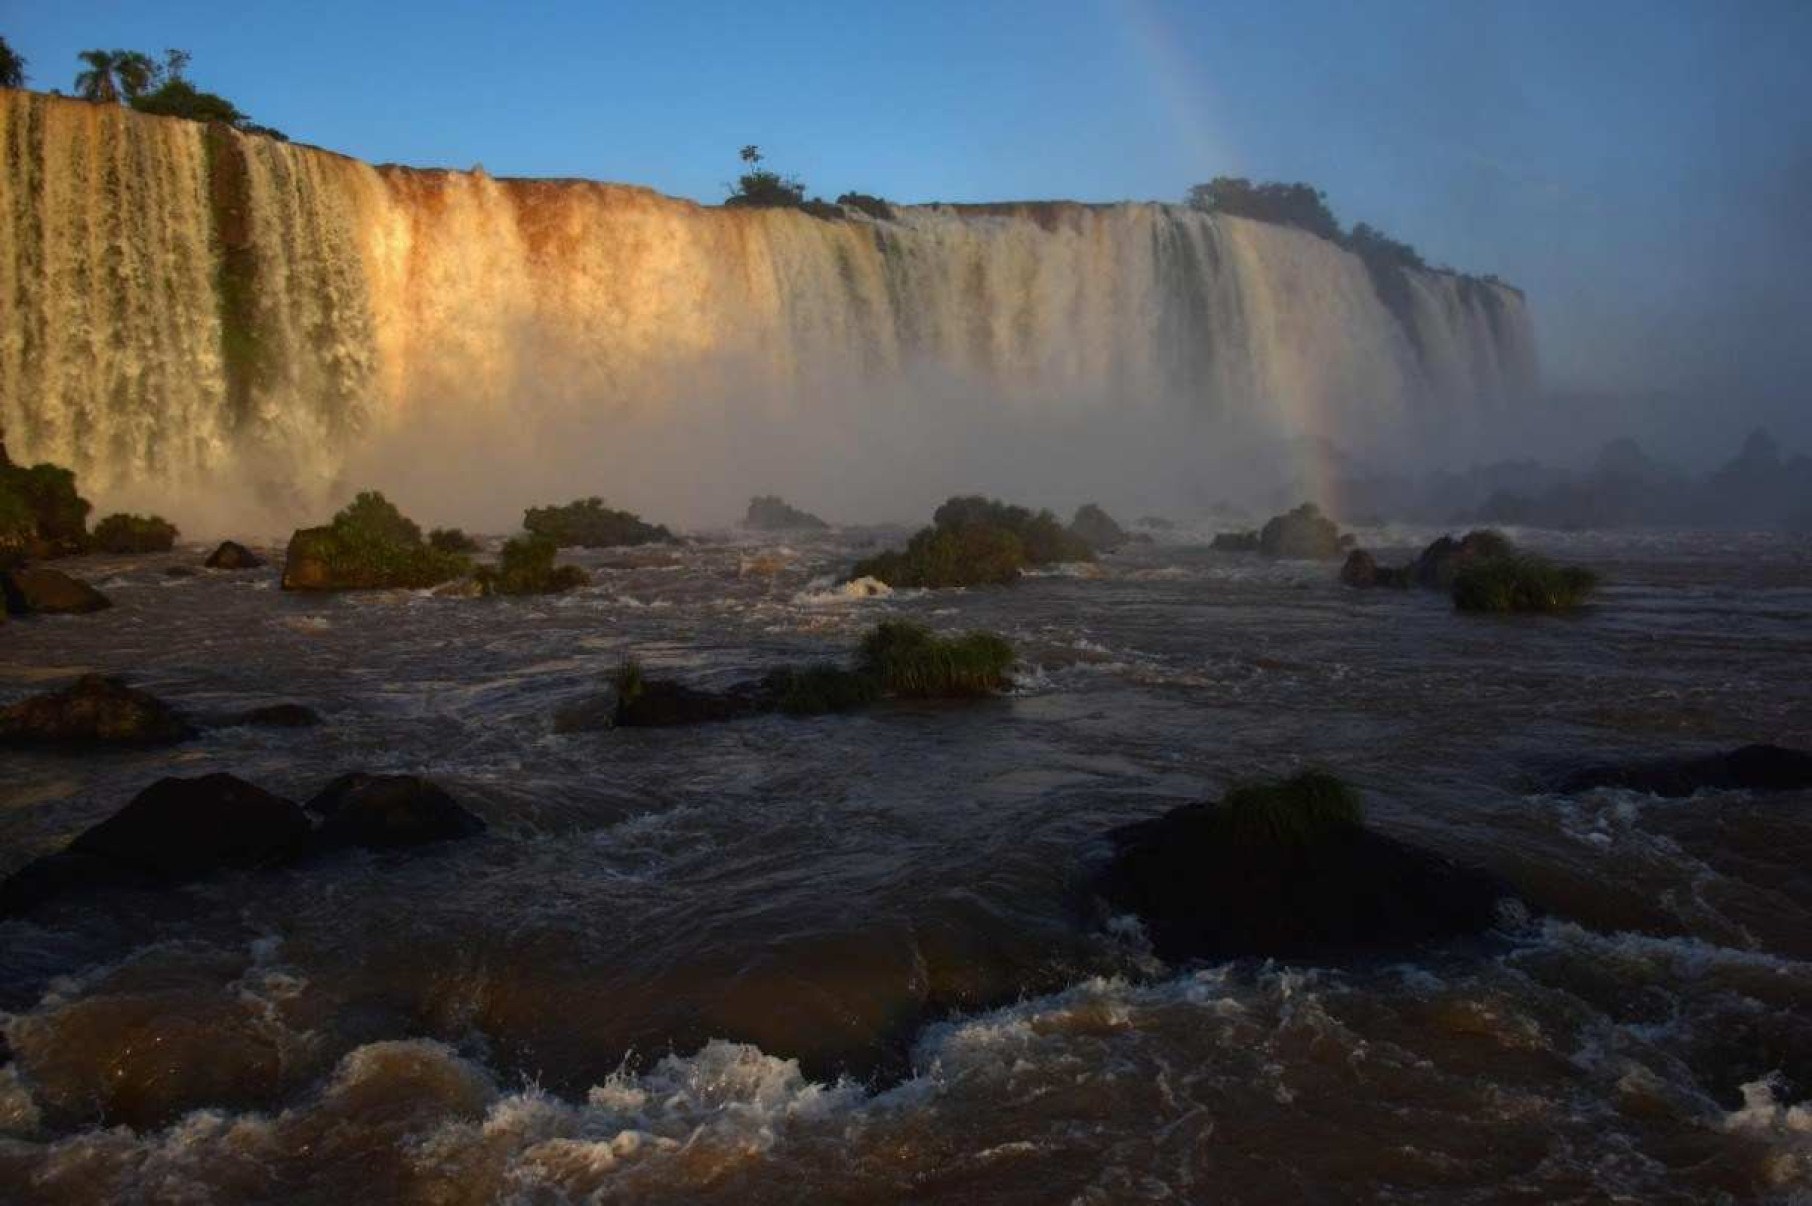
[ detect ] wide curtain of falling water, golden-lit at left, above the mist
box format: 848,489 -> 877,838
0,92 -> 1535,489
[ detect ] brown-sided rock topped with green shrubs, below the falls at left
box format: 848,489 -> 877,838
283,491 -> 471,590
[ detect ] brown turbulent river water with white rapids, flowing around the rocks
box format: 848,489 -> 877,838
0,531 -> 1812,1202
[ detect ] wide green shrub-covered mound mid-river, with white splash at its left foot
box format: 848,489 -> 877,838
850,494 -> 1094,589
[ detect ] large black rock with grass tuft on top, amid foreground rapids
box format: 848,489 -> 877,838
1096,771 -> 1509,962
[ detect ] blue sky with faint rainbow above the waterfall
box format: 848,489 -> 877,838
0,0 -> 1812,450
